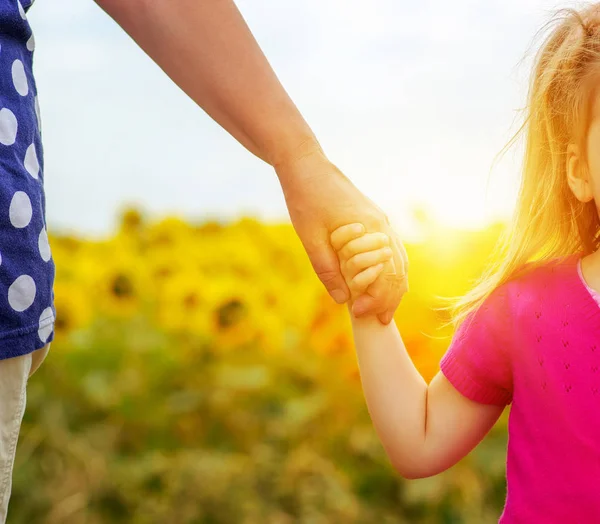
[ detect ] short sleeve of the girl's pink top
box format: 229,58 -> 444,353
440,286 -> 512,406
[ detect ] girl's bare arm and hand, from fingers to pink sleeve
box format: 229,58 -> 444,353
331,226 -> 506,479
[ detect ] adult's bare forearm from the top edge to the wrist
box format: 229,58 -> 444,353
96,0 -> 318,170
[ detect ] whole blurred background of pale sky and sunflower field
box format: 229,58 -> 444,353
9,0 -> 573,524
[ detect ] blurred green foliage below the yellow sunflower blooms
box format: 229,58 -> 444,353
9,318 -> 506,524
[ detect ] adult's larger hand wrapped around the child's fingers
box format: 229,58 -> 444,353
274,141 -> 408,324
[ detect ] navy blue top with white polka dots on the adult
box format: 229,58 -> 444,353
0,0 -> 56,360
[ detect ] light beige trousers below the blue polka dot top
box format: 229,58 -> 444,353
0,342 -> 51,524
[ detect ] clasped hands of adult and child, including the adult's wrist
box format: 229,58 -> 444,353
274,142 -> 408,324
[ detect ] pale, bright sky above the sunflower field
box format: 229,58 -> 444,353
28,0 -> 572,239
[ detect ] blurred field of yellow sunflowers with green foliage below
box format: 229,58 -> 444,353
8,207 -> 507,524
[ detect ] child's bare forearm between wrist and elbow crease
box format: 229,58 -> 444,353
349,308 -> 428,477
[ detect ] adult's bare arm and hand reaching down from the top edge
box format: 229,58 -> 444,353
96,0 -> 407,322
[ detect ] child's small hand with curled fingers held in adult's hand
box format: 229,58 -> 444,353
331,224 -> 392,303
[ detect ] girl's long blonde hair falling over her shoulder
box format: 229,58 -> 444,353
439,3 -> 600,328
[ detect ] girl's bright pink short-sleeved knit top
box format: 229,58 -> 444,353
440,252 -> 600,524
